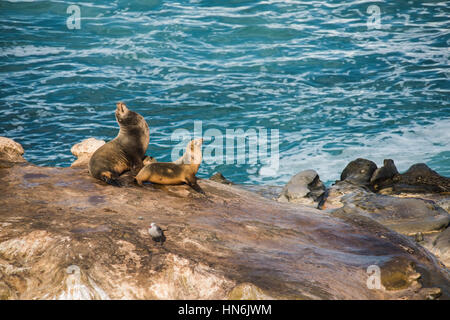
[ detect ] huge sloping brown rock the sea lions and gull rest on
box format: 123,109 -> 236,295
0,163 -> 450,299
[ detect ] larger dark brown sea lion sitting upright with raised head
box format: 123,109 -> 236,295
89,102 -> 150,187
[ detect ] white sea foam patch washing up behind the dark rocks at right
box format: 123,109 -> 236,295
277,118 -> 450,183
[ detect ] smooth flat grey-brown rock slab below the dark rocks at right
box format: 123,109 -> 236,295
341,192 -> 450,235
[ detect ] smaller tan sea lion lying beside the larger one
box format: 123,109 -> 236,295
135,138 -> 204,194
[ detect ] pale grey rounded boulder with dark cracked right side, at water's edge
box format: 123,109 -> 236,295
278,170 -> 325,204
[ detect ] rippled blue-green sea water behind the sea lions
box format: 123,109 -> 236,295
0,0 -> 450,184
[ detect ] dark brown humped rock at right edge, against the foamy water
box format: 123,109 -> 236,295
393,163 -> 450,193
